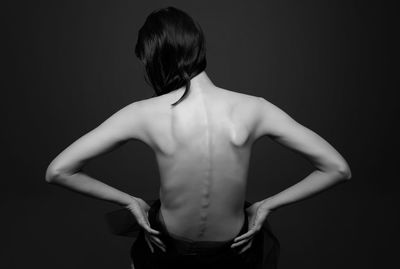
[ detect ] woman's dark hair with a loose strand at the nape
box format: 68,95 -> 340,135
135,6 -> 207,106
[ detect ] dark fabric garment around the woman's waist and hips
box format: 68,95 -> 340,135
131,199 -> 280,269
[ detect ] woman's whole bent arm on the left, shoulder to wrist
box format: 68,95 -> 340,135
45,102 -> 144,206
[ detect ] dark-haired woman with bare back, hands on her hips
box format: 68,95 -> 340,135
46,7 -> 351,268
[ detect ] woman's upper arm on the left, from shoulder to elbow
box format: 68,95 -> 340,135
46,102 -> 144,177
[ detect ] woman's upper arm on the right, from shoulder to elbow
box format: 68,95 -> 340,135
257,98 -> 350,175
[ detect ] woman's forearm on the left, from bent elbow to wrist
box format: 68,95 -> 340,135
48,172 -> 137,206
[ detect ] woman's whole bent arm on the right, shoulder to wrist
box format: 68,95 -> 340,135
256,97 -> 352,211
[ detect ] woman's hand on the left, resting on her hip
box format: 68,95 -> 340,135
126,197 -> 165,253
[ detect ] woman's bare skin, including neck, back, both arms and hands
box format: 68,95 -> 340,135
46,72 -> 351,258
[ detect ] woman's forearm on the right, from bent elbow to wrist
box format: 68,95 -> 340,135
261,170 -> 346,210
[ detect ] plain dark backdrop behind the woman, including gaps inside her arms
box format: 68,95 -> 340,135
0,0 -> 399,269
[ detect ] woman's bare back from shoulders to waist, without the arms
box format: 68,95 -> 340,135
142,87 -> 255,241
